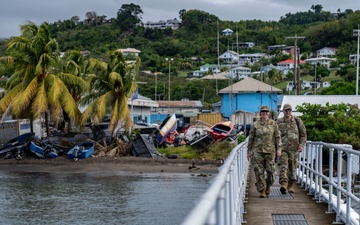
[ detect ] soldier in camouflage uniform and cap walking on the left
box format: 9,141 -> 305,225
248,106 -> 281,198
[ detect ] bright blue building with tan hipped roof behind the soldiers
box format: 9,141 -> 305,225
219,77 -> 282,118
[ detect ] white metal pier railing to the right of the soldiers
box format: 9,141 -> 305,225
297,142 -> 360,225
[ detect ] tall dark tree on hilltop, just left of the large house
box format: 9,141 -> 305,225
116,3 -> 143,31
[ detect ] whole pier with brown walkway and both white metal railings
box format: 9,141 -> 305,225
181,140 -> 360,225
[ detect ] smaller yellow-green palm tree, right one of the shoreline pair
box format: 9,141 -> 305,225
81,51 -> 140,137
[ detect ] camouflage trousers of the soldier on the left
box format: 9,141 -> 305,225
252,152 -> 275,192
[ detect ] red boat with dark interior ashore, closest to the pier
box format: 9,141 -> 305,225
208,121 -> 236,142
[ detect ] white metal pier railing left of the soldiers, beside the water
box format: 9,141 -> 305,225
181,139 -> 249,225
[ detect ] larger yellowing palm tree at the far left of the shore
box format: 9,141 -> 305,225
0,21 -> 80,135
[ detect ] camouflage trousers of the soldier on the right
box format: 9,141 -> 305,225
279,151 -> 298,183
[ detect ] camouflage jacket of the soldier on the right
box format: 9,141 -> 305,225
276,116 -> 306,151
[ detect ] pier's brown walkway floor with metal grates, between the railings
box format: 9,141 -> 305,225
244,169 -> 336,225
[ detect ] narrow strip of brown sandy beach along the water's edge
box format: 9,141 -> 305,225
0,156 -> 221,174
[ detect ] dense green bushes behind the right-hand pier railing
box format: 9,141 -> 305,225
297,103 -> 360,149
